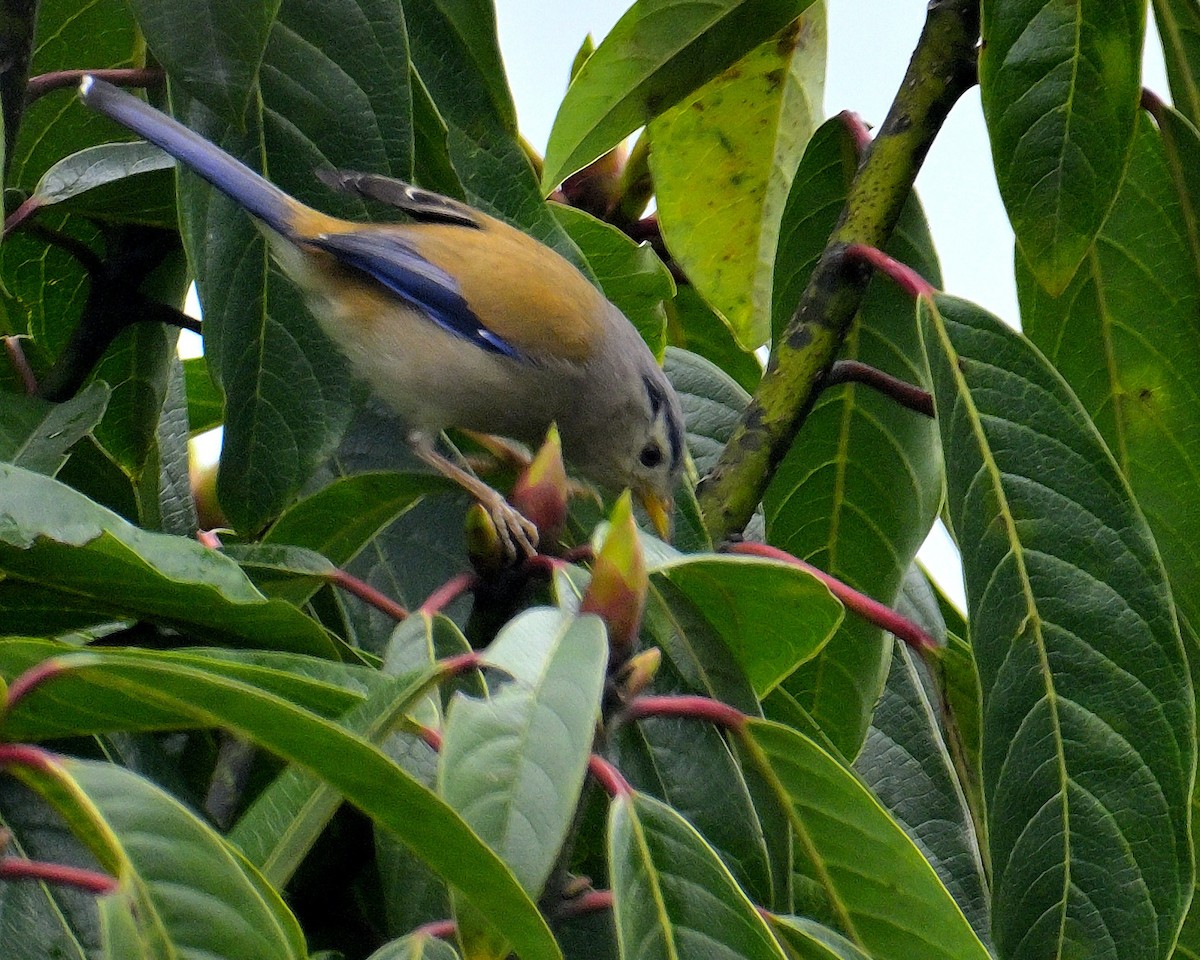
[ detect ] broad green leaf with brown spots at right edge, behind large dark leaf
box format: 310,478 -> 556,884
1018,110 -> 1200,643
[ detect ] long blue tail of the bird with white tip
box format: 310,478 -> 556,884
79,77 -> 302,236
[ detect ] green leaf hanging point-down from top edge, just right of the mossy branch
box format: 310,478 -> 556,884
979,0 -> 1146,295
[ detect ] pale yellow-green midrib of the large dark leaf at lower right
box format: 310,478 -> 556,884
926,300 -> 1070,956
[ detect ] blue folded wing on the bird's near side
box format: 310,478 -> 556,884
304,232 -> 527,361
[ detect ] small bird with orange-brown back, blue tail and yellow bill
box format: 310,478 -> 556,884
79,77 -> 684,556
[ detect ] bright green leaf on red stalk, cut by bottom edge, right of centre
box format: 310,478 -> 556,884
745,720 -> 989,960
